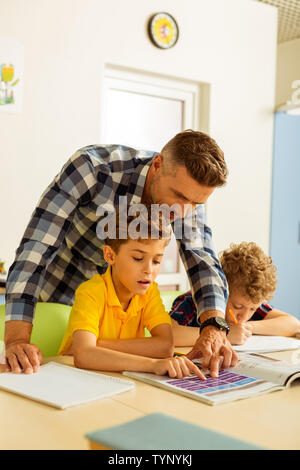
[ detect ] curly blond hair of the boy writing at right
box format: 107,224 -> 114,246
220,242 -> 277,303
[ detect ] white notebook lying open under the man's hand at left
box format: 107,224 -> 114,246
0,362 -> 135,409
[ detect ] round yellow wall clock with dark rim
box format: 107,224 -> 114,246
148,13 -> 178,49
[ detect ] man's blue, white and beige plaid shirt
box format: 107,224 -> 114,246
6,145 -> 227,322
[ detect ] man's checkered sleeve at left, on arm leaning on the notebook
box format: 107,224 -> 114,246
6,151 -> 97,322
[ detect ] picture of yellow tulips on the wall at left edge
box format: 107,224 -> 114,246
0,37 -> 24,113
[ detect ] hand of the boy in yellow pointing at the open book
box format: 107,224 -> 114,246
153,356 -> 206,380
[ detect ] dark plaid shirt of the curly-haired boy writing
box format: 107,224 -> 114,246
170,291 -> 272,328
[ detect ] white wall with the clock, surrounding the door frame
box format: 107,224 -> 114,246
0,0 -> 277,265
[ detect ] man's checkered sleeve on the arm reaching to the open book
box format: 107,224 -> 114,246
175,204 -> 228,319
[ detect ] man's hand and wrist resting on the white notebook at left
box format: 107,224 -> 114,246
0,321 -> 43,374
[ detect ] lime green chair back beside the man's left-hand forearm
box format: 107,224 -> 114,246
0,302 -> 71,357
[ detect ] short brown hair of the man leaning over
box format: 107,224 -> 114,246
161,129 -> 228,187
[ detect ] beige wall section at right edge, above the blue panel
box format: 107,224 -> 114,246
276,39 -> 300,106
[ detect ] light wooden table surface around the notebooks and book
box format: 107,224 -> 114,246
0,351 -> 300,449
